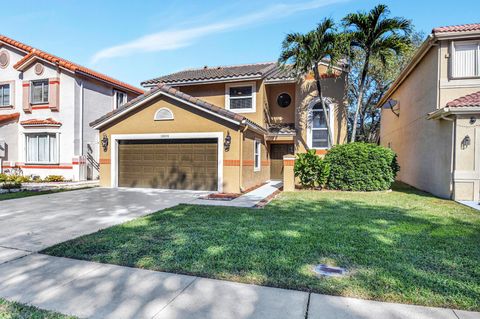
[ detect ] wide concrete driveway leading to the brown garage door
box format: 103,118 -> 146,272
0,188 -> 206,255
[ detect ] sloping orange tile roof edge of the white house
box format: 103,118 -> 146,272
0,34 -> 143,94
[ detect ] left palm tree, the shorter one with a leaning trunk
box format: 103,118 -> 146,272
278,19 -> 338,149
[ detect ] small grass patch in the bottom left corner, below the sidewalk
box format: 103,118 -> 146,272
0,298 -> 76,319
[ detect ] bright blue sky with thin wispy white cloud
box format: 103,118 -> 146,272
0,0 -> 480,85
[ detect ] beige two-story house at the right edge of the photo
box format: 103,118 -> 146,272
379,24 -> 480,201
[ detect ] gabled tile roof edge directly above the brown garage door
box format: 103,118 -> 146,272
90,84 -> 266,132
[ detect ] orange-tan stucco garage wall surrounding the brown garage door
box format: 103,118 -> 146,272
100,98 -> 270,193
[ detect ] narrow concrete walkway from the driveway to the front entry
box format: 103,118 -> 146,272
190,181 -> 283,208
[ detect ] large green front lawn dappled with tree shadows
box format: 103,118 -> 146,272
45,185 -> 480,311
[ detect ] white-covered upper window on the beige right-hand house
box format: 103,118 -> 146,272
452,42 -> 480,78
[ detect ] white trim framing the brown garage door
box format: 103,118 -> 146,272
110,132 -> 223,192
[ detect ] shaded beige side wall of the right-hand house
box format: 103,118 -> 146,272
380,47 -> 453,198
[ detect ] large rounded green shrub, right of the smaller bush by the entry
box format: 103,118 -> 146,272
325,143 -> 400,191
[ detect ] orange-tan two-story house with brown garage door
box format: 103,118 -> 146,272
91,63 -> 347,193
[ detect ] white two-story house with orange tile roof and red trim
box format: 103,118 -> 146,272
0,35 -> 143,180
